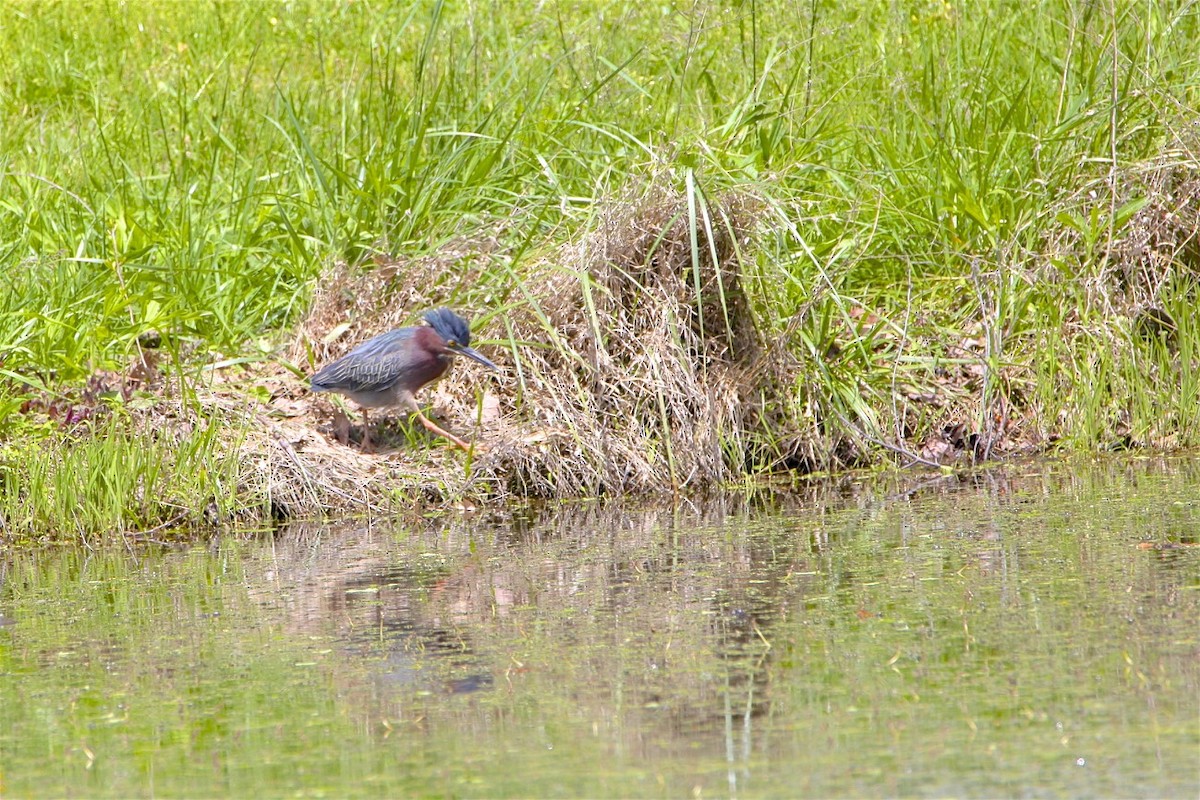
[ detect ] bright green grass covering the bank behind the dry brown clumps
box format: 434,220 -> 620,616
0,0 -> 1200,537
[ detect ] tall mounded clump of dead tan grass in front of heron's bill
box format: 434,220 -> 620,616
468,181 -> 782,497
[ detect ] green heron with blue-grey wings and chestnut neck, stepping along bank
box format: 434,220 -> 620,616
312,308 -> 499,450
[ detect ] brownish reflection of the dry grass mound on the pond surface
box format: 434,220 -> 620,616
242,504 -> 824,796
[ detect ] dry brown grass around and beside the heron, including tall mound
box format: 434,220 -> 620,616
245,181 -> 808,512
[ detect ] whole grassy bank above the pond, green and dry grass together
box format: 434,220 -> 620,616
0,0 -> 1200,536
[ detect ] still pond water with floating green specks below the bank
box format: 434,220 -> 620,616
0,459 -> 1200,798
